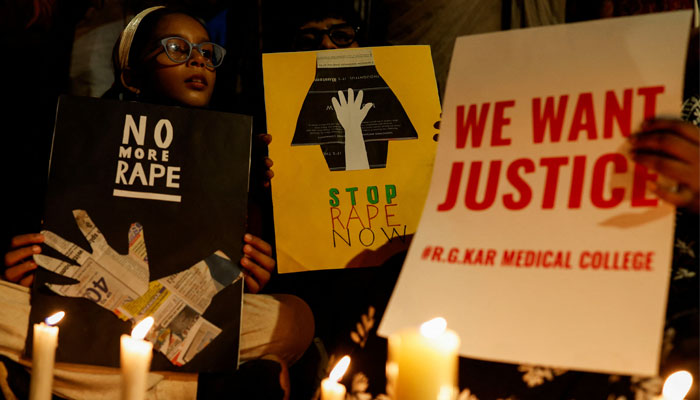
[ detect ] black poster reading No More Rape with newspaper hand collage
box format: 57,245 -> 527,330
25,96 -> 252,372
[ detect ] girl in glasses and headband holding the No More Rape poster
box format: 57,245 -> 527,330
4,7 -> 314,395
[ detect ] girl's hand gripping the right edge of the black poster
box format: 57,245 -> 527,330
241,233 -> 275,293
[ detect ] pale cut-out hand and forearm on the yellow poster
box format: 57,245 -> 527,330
331,88 -> 372,171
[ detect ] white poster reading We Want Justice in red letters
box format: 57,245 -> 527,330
380,12 -> 690,375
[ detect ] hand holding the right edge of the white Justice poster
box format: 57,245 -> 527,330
629,119 -> 700,213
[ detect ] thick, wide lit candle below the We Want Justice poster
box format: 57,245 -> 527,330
387,318 -> 459,400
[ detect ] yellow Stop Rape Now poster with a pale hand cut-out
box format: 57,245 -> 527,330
263,46 -> 440,273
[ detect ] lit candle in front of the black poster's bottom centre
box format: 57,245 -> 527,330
120,317 -> 153,400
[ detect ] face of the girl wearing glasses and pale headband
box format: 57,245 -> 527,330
143,14 -> 216,107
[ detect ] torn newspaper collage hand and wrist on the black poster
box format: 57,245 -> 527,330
34,210 -> 241,365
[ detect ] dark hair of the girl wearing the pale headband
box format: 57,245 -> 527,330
102,7 -> 209,100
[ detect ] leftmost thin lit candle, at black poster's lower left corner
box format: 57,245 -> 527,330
29,311 -> 66,400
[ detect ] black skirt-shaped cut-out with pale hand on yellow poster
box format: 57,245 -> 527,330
291,48 -> 418,171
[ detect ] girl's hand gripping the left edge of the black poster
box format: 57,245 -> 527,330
3,233 -> 44,287
